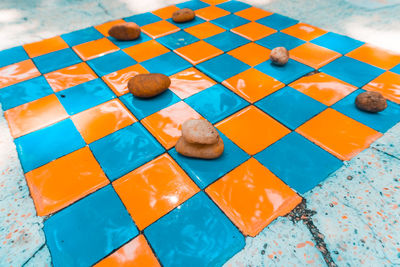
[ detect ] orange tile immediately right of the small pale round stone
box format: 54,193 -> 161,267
290,43 -> 342,69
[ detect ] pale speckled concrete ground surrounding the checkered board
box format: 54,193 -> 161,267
0,0 -> 400,266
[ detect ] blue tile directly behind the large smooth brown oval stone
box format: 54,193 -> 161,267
140,52 -> 192,76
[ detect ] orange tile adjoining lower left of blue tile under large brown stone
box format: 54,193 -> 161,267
71,99 -> 136,144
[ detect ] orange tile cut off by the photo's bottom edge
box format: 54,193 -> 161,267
94,235 -> 161,267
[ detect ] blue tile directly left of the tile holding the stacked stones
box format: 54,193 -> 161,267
89,122 -> 164,181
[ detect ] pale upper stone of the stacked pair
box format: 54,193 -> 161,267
182,120 -> 219,145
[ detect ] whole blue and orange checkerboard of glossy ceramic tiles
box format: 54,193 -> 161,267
0,0 -> 400,266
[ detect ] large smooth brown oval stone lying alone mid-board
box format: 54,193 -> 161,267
128,73 -> 171,98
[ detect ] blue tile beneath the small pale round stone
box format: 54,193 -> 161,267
255,59 -> 314,84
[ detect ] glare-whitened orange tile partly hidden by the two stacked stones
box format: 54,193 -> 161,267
142,102 -> 202,149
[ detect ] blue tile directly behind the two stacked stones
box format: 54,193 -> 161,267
185,84 -> 249,124
